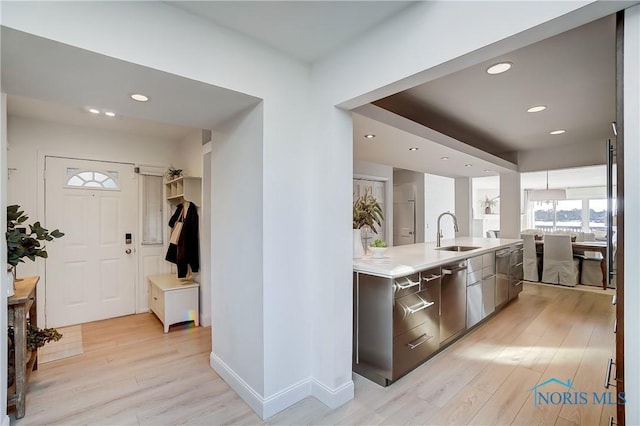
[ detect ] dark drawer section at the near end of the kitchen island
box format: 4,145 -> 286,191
353,268 -> 441,386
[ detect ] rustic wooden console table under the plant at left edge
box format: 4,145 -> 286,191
7,277 -> 40,419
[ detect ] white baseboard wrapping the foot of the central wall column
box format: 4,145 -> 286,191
209,352 -> 354,420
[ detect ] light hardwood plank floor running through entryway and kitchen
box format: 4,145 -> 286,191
10,284 -> 615,426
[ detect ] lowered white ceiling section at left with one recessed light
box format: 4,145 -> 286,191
1,27 -> 259,135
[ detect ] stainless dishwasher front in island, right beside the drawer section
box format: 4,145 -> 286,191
440,260 -> 467,344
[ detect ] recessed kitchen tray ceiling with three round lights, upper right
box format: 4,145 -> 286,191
376,15 -> 616,163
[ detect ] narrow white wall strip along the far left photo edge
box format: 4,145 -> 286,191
0,93 -> 9,426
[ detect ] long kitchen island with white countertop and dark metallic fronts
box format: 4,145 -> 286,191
353,237 -> 522,386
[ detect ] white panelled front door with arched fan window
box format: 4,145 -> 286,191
45,157 -> 137,327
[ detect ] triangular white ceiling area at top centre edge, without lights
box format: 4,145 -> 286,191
166,1 -> 417,63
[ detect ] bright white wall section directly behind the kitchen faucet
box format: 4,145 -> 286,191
424,173 -> 456,242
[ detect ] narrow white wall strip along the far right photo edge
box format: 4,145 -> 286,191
624,6 -> 640,425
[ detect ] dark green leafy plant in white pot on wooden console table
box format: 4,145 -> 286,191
5,205 -> 64,292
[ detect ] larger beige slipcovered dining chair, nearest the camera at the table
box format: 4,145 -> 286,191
542,234 -> 580,287
